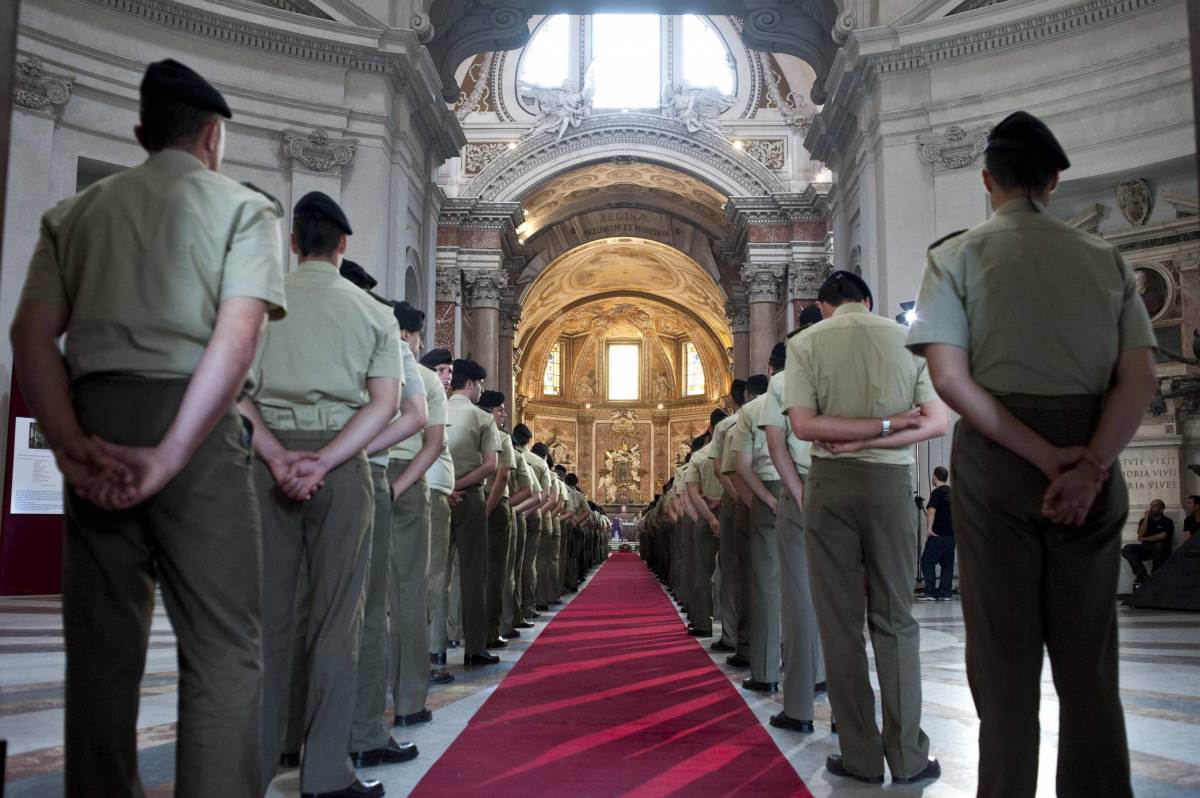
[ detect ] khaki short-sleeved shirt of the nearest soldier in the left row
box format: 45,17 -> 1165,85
22,150 -> 287,380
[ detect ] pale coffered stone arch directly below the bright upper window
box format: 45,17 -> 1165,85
463,114 -> 786,202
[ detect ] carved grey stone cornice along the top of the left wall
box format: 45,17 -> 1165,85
80,0 -> 467,160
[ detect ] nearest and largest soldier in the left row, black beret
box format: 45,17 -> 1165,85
12,60 -> 286,798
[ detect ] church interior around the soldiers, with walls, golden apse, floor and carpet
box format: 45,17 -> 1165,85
0,0 -> 1200,798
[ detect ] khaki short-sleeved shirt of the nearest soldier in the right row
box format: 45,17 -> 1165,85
908,199 -> 1157,396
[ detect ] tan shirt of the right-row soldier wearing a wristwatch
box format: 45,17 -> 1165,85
784,302 -> 937,466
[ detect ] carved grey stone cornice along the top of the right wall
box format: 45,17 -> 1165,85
804,0 -> 1175,162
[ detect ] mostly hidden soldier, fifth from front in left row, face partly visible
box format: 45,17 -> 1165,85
420,349 -> 454,684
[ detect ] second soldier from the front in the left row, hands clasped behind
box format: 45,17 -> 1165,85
239,192 -> 412,796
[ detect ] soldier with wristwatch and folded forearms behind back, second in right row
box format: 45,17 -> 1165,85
784,271 -> 949,784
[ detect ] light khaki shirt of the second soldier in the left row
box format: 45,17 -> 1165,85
252,260 -> 404,431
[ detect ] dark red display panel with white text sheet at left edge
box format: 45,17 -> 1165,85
0,376 -> 62,595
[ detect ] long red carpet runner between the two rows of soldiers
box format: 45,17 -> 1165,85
413,553 -> 811,798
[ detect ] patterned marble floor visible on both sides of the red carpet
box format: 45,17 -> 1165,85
0,564 -> 1200,798
